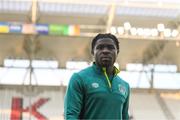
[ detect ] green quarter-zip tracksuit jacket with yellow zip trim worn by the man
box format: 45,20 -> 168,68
64,64 -> 130,120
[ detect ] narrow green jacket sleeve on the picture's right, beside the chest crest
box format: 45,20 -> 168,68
122,85 -> 130,120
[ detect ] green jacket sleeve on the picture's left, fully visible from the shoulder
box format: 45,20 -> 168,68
64,73 -> 84,120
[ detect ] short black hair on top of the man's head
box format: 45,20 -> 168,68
91,33 -> 119,54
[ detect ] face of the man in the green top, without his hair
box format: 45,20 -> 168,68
93,38 -> 117,67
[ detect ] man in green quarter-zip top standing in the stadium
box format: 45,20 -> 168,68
64,34 -> 130,120
